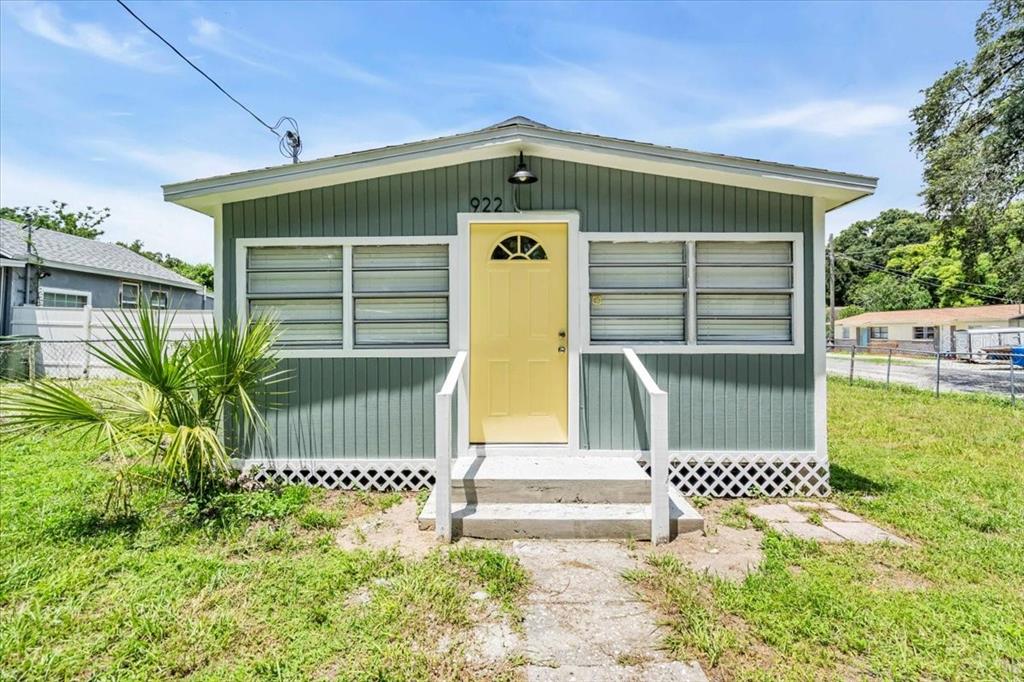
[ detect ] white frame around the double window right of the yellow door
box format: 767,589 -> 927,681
573,231 -> 802,355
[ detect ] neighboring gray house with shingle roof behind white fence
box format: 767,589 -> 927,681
0,219 -> 213,335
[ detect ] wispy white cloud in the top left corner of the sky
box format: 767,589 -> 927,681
7,2 -> 167,71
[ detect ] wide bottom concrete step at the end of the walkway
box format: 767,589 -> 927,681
419,479 -> 703,540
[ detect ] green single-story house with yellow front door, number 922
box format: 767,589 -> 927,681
164,117 -> 877,534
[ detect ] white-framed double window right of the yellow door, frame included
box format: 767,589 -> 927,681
583,232 -> 803,353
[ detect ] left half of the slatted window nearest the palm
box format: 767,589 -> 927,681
246,246 -> 345,347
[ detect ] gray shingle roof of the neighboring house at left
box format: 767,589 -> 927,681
0,219 -> 202,291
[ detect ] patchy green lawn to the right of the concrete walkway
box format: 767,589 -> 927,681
629,379 -> 1024,680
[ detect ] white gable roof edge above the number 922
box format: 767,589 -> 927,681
164,127 -> 877,215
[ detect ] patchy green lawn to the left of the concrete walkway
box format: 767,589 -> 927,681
0,425 -> 525,680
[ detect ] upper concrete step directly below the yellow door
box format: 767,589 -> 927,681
452,456 -> 650,504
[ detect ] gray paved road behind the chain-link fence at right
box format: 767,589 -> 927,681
826,354 -> 1024,399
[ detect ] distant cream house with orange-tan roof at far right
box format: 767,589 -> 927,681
836,303 -> 1024,352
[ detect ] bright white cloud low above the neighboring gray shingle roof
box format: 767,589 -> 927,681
0,155 -> 213,262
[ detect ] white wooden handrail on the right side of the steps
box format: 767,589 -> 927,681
623,348 -> 671,545
